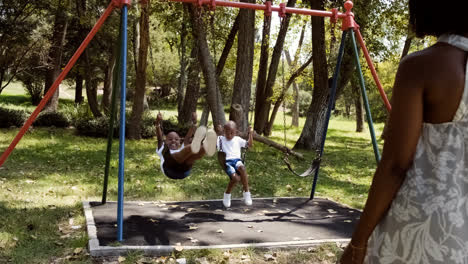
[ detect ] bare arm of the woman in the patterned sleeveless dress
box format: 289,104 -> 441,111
341,56 -> 424,263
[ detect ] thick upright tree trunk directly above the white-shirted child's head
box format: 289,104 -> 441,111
229,0 -> 255,132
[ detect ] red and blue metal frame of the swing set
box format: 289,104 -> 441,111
0,0 -> 391,241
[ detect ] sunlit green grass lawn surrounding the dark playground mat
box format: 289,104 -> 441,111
0,94 -> 383,263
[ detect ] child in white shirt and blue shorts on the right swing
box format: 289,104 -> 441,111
217,121 -> 253,208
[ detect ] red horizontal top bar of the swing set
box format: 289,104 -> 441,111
171,0 -> 346,18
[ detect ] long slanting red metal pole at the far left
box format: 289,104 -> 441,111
0,1 -> 116,166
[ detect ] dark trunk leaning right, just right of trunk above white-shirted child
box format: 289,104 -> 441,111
256,0 -> 296,135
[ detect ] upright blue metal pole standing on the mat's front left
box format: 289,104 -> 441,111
117,5 -> 128,241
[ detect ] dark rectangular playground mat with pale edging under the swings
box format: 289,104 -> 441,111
83,197 -> 361,256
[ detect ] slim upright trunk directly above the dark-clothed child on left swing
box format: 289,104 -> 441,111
177,8 -> 187,116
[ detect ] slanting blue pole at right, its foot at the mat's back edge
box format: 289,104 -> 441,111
310,31 -> 348,200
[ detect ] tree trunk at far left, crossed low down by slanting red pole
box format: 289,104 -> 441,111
44,0 -> 68,112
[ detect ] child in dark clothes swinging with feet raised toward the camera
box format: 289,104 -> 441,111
155,113 -> 217,180
